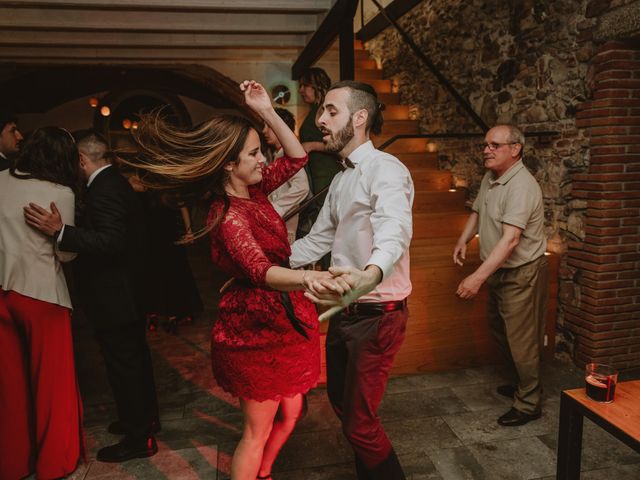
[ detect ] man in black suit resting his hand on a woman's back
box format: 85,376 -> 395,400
25,131 -> 160,462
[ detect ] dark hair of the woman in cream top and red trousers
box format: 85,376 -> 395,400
11,127 -> 80,192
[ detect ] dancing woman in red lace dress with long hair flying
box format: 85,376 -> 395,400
131,81 -> 349,480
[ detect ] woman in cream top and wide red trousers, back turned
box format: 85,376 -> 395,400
0,127 -> 82,480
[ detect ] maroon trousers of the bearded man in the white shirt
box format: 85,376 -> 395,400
326,307 -> 409,480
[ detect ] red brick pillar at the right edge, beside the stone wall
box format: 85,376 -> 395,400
565,42 -> 640,369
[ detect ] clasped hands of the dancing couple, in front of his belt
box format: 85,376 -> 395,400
303,266 -> 381,321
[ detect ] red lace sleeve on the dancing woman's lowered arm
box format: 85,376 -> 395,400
219,205 -> 273,286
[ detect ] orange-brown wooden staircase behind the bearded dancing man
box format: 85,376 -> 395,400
318,42 -> 557,374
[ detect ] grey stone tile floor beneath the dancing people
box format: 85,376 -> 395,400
67,318 -> 640,480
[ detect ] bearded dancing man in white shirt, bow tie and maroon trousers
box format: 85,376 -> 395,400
290,81 -> 414,480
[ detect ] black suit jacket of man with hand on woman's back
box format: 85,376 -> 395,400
60,166 -> 143,328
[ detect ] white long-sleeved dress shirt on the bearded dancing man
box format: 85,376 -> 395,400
290,141 -> 414,302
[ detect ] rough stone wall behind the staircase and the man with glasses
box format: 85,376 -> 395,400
367,0 -> 640,370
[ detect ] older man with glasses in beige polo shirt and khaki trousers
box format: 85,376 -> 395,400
453,125 -> 549,427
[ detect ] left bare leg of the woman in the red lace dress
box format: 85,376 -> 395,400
231,400 -> 280,480
